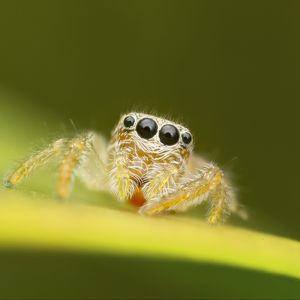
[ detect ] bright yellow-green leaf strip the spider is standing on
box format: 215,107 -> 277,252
0,190 -> 300,278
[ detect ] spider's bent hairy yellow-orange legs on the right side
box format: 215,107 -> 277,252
141,163 -> 244,224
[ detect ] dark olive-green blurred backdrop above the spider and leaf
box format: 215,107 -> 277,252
0,0 -> 300,298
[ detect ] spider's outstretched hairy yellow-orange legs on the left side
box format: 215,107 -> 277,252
4,132 -> 106,199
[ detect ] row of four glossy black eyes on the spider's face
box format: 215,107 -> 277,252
123,116 -> 192,146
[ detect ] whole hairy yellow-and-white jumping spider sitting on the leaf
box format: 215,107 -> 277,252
5,112 -> 246,224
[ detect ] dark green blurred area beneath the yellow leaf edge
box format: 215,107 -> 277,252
0,251 -> 300,299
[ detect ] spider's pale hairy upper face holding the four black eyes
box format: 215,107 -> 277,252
113,112 -> 193,163
